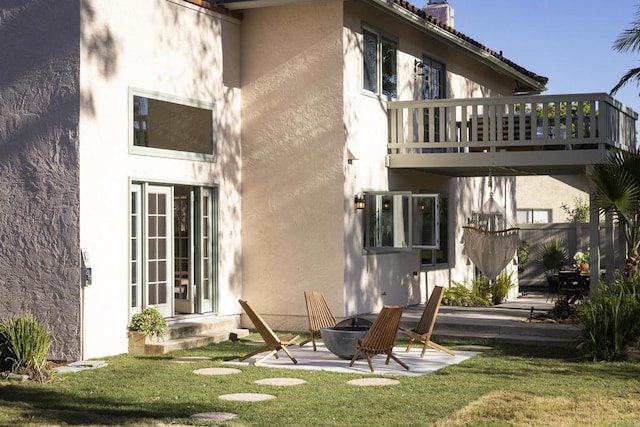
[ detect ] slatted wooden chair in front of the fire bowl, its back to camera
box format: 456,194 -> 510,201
349,305 -> 409,372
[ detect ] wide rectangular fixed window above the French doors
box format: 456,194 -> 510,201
129,92 -> 216,161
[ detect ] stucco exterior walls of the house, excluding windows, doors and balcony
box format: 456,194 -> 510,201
0,0 -> 548,358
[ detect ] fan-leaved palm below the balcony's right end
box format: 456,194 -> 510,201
590,150 -> 640,274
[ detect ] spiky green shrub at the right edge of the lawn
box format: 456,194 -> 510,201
578,276 -> 640,361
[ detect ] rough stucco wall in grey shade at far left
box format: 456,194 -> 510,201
0,0 -> 81,359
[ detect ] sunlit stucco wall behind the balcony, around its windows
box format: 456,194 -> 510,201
344,1 -> 515,314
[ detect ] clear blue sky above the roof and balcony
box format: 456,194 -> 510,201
448,0 -> 640,117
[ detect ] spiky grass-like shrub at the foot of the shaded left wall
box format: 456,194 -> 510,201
0,314 -> 51,382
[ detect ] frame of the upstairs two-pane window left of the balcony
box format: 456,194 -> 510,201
361,24 -> 399,101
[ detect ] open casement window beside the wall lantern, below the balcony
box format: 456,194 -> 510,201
364,191 -> 440,252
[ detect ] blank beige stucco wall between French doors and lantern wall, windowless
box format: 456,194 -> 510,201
242,1 -> 345,329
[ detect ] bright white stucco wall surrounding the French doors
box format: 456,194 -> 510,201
80,0 -> 242,357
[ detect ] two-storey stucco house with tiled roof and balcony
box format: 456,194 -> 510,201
0,0 -> 636,360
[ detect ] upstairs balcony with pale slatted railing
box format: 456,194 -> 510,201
386,93 -> 638,176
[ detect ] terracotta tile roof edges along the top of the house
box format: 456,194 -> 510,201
210,0 -> 549,93
